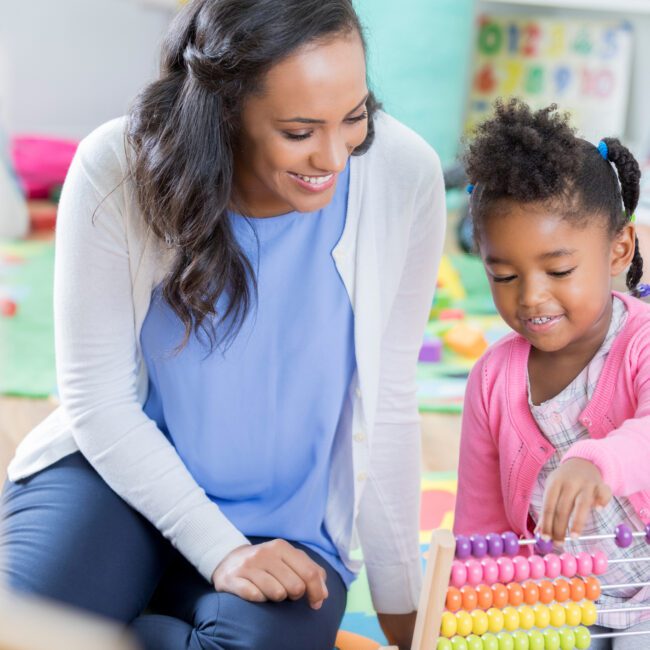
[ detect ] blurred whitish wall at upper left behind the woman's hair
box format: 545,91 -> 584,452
0,0 -> 173,138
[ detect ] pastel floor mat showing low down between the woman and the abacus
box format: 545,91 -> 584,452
341,472 -> 456,643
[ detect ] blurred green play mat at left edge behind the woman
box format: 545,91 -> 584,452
0,241 -> 56,397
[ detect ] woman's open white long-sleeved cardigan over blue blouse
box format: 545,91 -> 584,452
9,113 -> 446,613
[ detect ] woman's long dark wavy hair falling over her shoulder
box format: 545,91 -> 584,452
126,0 -> 378,347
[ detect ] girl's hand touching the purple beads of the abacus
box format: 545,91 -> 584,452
537,458 -> 612,543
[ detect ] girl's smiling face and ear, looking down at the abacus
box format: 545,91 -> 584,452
479,204 -> 634,356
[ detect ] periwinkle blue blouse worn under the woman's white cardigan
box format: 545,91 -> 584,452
141,164 -> 356,586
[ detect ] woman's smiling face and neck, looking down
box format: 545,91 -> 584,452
235,32 -> 368,217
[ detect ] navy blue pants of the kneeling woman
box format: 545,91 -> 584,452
0,453 -> 347,650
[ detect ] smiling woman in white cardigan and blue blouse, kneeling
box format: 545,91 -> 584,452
0,0 -> 445,650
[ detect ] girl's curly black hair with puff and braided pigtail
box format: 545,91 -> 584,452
464,99 -> 643,291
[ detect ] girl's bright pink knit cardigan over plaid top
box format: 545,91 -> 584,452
454,292 -> 650,537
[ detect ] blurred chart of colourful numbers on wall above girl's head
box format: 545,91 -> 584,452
466,15 -> 632,141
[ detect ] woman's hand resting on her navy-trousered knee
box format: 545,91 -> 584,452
212,539 -> 328,609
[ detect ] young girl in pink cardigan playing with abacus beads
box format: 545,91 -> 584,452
455,100 -> 650,650
